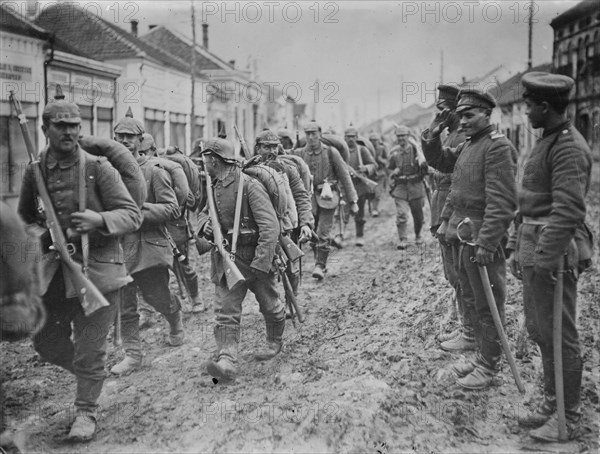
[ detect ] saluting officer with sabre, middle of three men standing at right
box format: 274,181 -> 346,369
423,89 -> 517,389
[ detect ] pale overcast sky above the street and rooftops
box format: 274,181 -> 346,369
51,0 -> 578,128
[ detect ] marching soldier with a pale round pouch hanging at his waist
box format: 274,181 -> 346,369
294,121 -> 358,280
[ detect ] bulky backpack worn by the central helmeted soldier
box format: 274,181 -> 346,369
242,156 -> 298,230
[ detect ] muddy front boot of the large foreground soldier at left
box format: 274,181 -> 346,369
67,377 -> 104,442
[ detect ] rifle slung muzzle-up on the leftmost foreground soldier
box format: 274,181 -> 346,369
9,90 -> 110,317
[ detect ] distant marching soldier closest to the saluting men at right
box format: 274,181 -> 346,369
388,125 -> 427,249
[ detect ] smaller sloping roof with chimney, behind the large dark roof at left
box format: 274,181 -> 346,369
140,25 -> 233,71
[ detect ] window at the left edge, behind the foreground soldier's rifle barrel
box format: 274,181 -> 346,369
0,102 -> 41,198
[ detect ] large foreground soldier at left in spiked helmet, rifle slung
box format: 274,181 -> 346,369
18,100 -> 142,441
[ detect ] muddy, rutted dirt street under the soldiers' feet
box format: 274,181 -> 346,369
1,165 -> 600,453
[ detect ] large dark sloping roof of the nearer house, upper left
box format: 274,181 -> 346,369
35,4 -> 189,72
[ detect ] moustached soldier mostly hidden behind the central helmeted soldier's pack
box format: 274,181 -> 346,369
254,130 -> 315,294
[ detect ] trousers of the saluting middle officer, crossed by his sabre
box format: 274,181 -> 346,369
458,245 -> 506,369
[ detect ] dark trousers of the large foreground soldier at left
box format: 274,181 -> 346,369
33,268 -> 120,413
